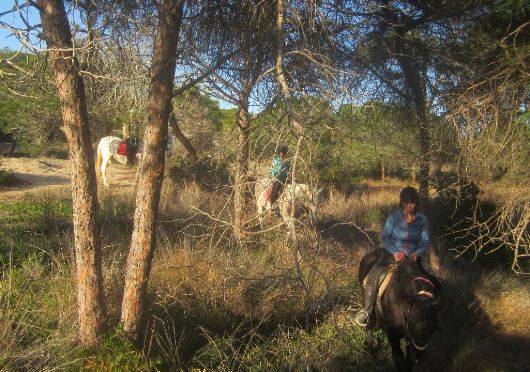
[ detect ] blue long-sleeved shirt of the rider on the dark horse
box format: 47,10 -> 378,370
382,208 -> 429,257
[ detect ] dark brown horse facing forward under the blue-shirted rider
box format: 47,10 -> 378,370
359,249 -> 441,371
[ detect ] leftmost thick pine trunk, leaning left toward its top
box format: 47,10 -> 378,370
38,0 -> 105,346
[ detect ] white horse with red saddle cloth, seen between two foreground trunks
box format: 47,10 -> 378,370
96,136 -> 143,187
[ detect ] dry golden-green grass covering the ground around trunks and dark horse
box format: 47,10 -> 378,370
0,179 -> 530,371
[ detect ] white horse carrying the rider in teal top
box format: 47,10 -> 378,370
254,178 -> 322,229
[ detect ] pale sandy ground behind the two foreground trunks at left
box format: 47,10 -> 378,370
0,157 -> 135,202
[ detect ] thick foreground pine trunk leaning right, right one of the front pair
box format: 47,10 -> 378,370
121,0 -> 184,340
